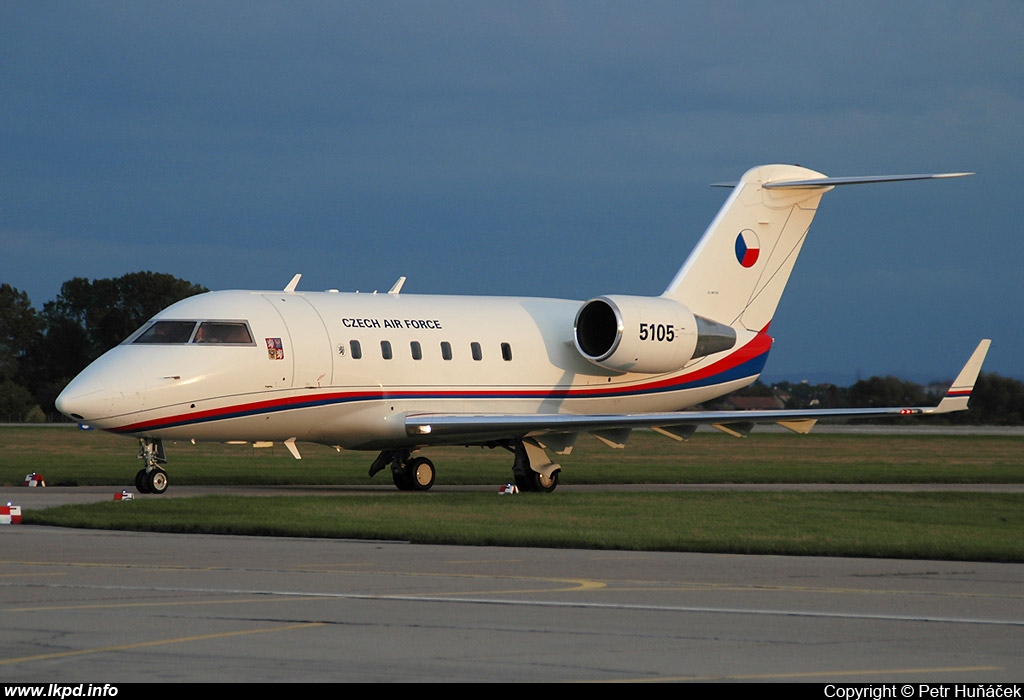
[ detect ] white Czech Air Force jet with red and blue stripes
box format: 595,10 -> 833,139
56,165 -> 990,494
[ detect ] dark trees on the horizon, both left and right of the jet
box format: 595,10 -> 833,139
0,272 -> 1024,425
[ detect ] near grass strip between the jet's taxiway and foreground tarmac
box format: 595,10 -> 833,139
25,491 -> 1024,562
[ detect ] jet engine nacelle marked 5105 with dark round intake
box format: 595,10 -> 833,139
574,295 -> 736,375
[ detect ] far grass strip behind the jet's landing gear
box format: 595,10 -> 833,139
0,427 -> 1024,488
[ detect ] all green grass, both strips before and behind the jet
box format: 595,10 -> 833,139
0,421 -> 1024,562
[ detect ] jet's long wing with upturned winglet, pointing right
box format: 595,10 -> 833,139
406,340 -> 990,447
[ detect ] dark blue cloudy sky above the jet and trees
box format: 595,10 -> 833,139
0,0 -> 1024,383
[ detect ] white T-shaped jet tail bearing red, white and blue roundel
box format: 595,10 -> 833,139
662,165 -> 971,332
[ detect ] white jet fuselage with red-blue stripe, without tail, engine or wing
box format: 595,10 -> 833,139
58,291 -> 771,449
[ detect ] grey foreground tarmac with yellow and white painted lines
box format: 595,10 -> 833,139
0,488 -> 1024,684
